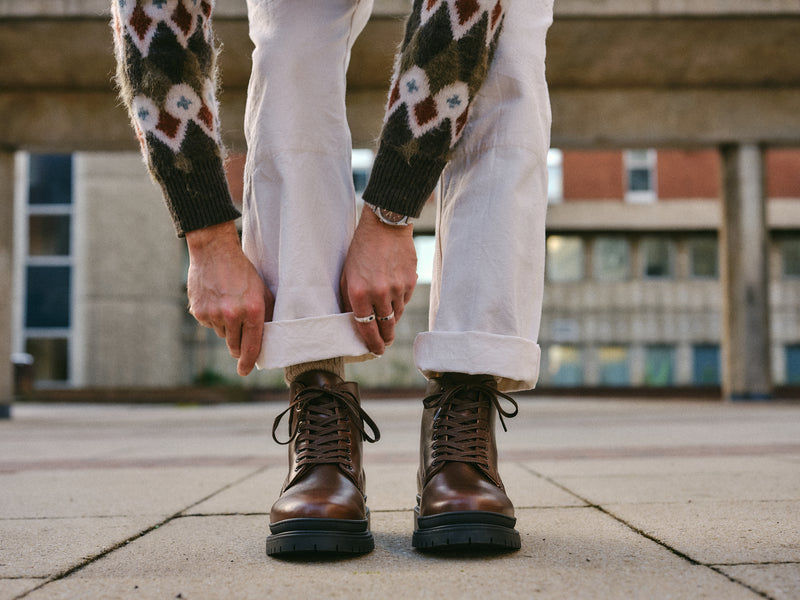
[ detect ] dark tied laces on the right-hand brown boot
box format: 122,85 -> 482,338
423,383 -> 519,470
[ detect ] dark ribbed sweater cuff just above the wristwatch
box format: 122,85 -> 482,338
363,148 -> 447,217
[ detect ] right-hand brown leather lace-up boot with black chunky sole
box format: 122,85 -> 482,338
411,373 -> 520,550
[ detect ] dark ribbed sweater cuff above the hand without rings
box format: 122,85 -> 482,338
160,160 -> 241,237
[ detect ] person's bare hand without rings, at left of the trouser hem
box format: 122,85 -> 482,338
186,221 -> 274,376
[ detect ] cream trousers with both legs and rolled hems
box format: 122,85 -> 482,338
243,0 -> 553,391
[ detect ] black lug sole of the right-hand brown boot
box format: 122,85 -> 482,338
411,510 -> 522,552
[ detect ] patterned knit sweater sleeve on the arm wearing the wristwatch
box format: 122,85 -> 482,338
363,0 -> 507,217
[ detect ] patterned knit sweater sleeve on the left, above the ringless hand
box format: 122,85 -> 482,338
111,0 -> 239,236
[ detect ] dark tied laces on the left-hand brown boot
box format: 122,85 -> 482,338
272,386 -> 381,471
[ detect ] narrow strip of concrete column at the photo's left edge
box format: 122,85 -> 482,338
0,151 -> 14,419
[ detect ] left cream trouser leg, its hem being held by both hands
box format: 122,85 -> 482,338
243,0 -> 372,368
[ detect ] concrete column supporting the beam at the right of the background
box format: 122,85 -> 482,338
720,144 -> 772,400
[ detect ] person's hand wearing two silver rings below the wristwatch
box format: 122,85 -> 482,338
341,206 -> 417,354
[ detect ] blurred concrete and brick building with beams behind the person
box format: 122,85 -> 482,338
0,0 -> 800,400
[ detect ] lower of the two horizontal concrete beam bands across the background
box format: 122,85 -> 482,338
6,87 -> 800,151
